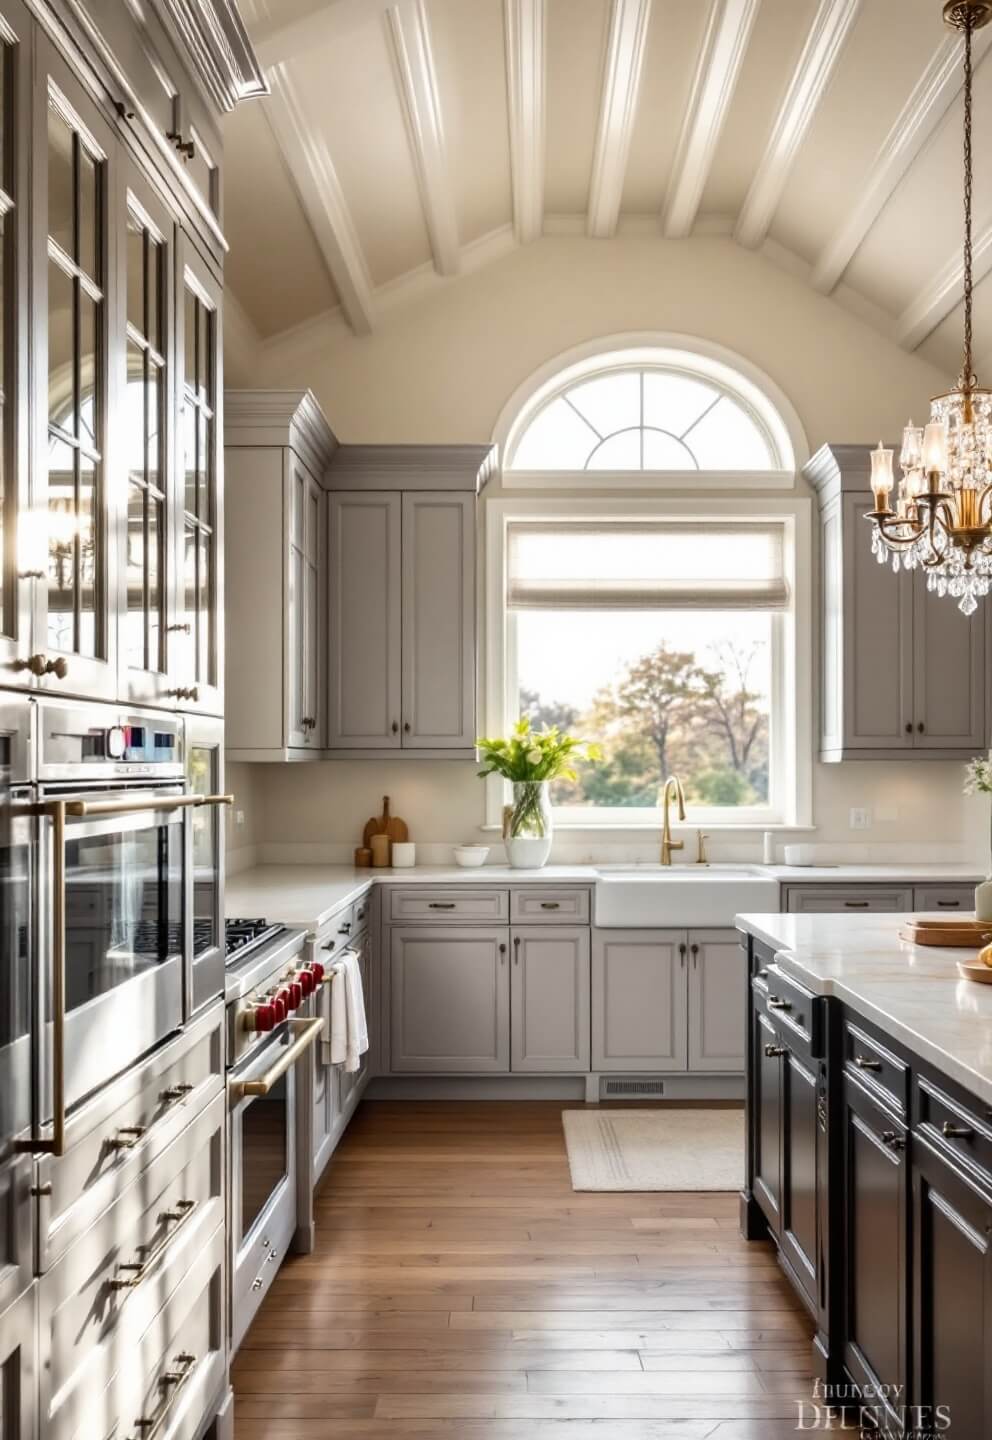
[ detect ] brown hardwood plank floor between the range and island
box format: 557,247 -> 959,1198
233,1102 -> 840,1440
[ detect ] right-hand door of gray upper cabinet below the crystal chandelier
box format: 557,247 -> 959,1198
907,575 -> 989,755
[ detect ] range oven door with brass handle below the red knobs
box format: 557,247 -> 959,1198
227,1018 -> 324,1349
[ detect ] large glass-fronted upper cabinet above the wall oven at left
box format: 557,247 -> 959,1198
0,0 -> 265,714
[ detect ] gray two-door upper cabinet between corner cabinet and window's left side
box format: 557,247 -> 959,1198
327,445 -> 491,759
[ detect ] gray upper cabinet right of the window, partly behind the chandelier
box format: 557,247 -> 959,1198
803,445 -> 992,760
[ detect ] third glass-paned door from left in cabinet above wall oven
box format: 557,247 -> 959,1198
118,161 -> 179,704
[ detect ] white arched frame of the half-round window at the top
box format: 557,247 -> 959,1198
494,331 -> 808,492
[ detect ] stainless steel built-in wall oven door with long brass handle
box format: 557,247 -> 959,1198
39,786 -> 186,1123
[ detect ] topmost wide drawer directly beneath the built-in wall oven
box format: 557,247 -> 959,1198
35,1001 -> 225,1272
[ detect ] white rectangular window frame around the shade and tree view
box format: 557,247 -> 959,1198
484,498 -> 813,834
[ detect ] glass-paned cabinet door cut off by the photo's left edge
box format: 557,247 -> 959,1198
0,0 -> 32,685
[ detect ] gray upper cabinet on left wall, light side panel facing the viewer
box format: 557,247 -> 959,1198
225,390 -> 337,760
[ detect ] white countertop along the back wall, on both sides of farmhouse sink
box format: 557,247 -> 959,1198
225,861 -> 979,932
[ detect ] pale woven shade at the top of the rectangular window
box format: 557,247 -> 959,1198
507,520 -> 789,611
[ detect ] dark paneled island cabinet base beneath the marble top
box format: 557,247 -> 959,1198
739,916 -> 992,1440
